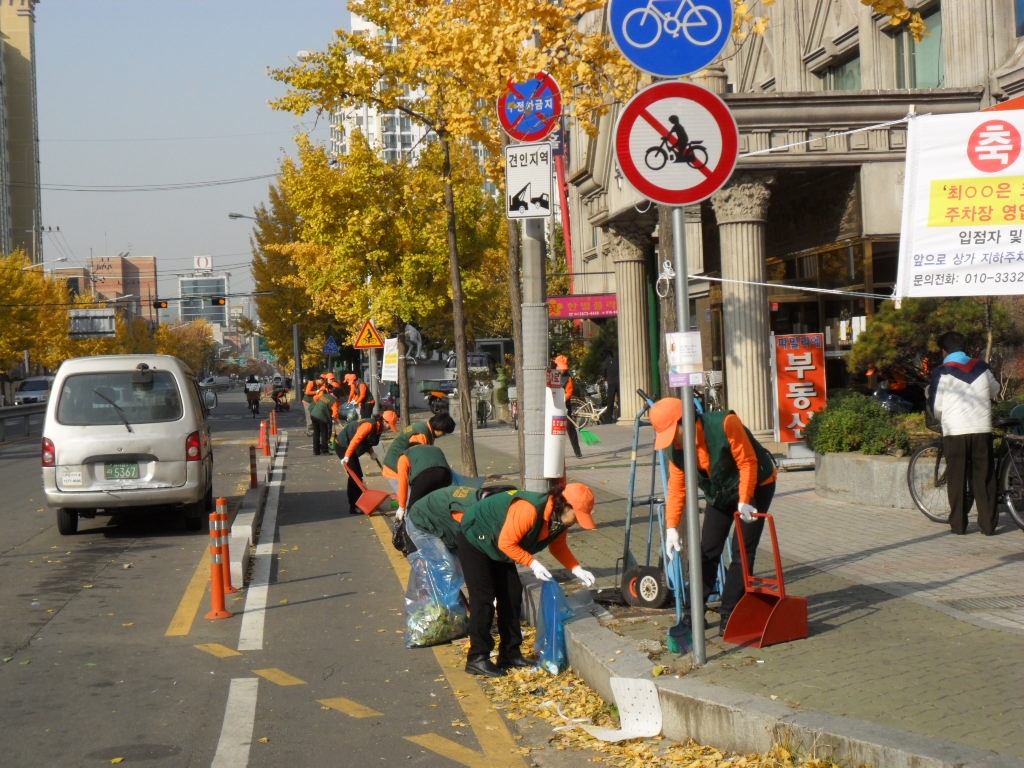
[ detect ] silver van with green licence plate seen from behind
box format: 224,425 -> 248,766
42,354 -> 217,536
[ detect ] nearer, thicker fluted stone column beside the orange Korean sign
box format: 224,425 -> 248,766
712,172 -> 774,440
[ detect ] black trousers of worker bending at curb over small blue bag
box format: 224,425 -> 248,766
456,531 -> 522,660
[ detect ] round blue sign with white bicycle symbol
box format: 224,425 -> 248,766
608,0 -> 732,78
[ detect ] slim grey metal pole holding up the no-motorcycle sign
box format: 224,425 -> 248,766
672,206 -> 707,665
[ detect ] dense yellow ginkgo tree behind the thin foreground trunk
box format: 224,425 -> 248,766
276,132 -> 509,434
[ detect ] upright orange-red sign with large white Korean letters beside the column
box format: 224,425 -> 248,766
775,334 -> 825,442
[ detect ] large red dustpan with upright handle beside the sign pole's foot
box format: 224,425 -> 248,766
722,512 -> 807,648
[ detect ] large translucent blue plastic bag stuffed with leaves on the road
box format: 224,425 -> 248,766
406,520 -> 469,648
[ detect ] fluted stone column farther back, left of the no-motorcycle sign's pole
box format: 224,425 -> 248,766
607,221 -> 653,423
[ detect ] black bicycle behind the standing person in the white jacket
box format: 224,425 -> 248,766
906,419 -> 1024,529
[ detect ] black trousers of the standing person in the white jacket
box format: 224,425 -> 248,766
942,432 -> 996,536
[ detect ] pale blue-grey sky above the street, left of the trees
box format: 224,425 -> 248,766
36,0 -> 348,295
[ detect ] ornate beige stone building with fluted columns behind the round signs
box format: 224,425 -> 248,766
568,0 -> 1024,437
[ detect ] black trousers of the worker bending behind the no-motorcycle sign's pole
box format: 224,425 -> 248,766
700,482 -> 775,616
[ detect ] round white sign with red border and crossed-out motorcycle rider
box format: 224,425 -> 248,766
615,81 -> 739,206
